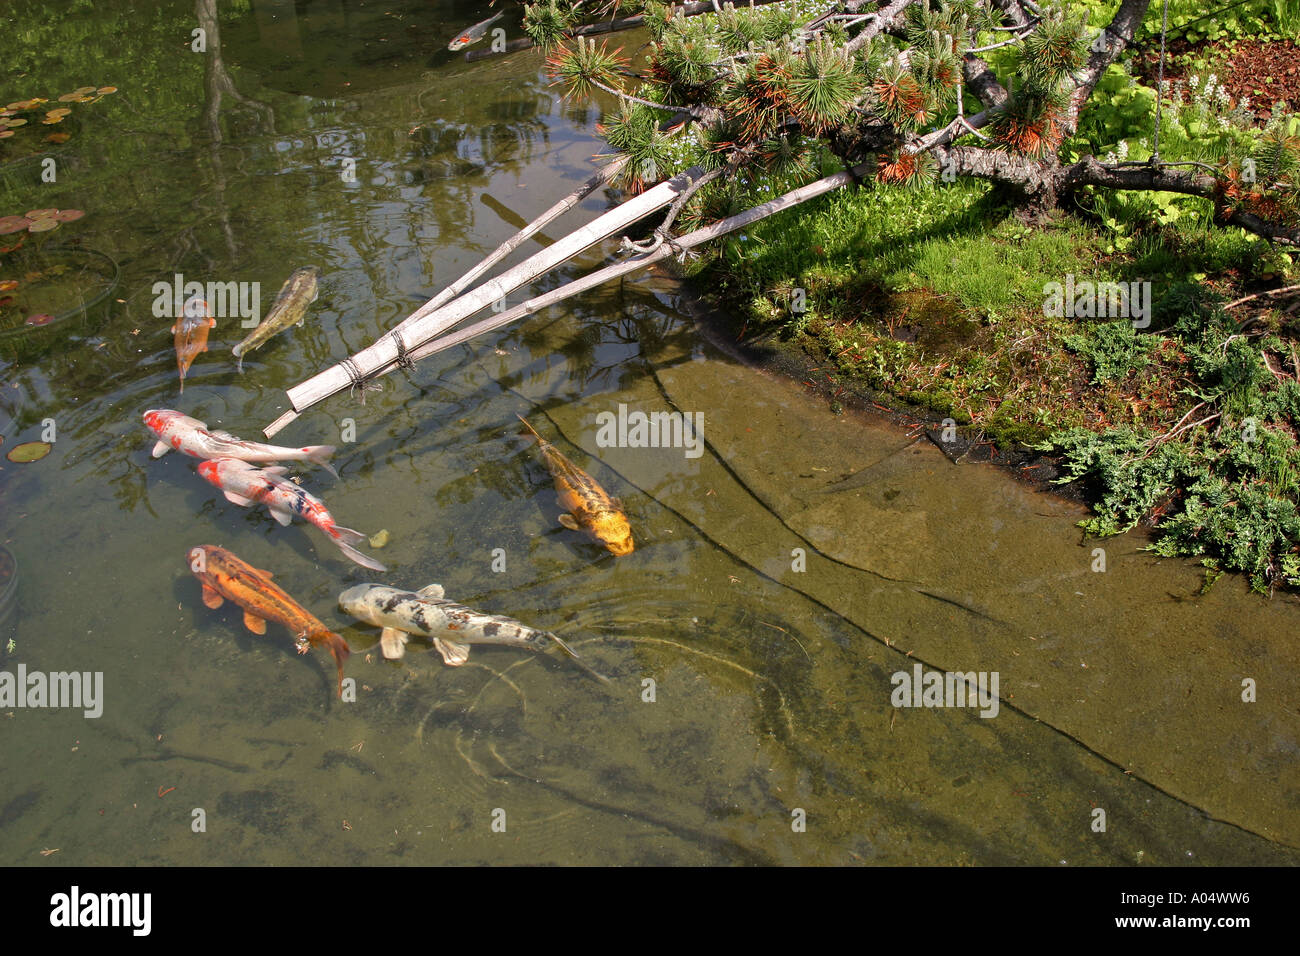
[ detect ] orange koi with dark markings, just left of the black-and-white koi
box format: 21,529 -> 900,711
186,545 -> 352,697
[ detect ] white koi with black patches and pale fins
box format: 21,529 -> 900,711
338,584 -> 608,683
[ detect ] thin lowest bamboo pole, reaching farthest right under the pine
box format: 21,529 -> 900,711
264,163 -> 874,438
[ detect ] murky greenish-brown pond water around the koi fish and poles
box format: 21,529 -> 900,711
0,0 -> 1300,864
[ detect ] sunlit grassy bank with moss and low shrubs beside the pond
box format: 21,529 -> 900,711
701,174 -> 1300,591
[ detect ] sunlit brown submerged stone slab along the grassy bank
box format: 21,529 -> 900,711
556,345 -> 1300,848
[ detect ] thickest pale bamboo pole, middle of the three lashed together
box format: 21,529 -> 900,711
263,166 -> 703,438
